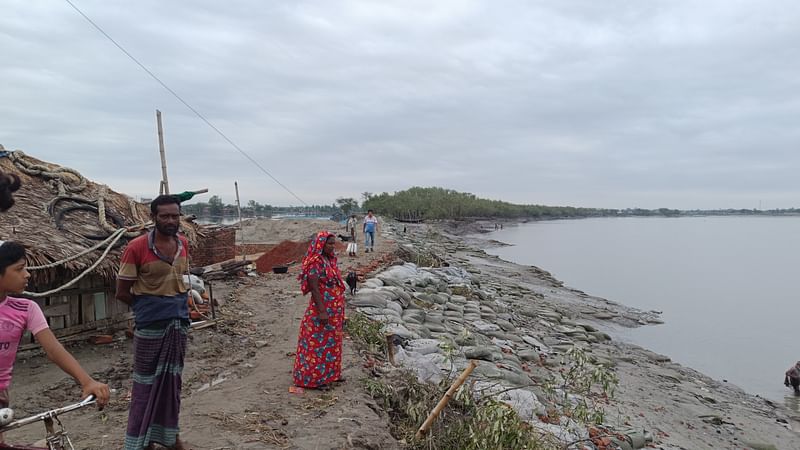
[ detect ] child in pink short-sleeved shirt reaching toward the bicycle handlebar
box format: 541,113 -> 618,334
0,241 -> 109,418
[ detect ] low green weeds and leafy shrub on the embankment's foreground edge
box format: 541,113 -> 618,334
358,342 -> 618,450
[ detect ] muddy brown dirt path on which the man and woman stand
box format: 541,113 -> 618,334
6,222 -> 398,450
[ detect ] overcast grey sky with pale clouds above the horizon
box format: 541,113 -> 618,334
0,0 -> 800,209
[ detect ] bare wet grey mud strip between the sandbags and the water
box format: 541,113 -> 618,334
372,217 -> 800,449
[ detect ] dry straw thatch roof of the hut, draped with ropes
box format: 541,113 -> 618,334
0,147 -> 197,291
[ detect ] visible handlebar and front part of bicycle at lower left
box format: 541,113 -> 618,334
0,395 -> 96,450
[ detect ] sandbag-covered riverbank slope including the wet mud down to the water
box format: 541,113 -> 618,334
374,221 -> 800,449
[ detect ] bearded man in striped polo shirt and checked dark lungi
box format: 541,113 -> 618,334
117,195 -> 189,450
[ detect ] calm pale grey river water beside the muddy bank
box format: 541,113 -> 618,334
488,216 -> 800,411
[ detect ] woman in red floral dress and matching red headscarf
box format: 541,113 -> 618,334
293,231 -> 345,388
